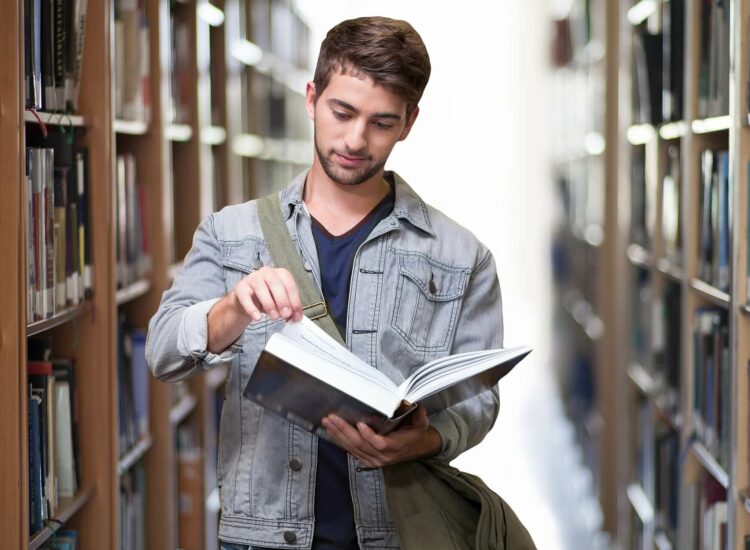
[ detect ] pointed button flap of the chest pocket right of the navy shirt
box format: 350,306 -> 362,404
399,253 -> 469,302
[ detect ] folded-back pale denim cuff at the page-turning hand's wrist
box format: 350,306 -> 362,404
177,298 -> 242,369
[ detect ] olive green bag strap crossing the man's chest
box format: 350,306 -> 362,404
258,193 -> 345,345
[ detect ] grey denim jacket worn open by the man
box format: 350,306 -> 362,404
146,172 -> 503,550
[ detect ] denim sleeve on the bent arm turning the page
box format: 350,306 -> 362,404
146,216 -> 242,382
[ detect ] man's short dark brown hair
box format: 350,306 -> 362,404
313,17 -> 431,116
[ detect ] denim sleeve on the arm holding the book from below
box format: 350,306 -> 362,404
430,251 -> 503,461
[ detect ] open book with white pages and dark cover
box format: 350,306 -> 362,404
243,317 -> 531,437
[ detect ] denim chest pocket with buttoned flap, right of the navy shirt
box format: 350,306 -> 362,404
391,251 -> 469,352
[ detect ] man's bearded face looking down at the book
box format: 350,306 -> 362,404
307,73 -> 418,185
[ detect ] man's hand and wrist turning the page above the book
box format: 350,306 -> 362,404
207,267 -> 302,354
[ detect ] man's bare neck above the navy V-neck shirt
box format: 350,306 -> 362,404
303,164 -> 390,235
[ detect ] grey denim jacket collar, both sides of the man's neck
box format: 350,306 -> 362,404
279,170 -> 435,237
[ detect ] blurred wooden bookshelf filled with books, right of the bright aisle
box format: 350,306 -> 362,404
555,0 -> 750,549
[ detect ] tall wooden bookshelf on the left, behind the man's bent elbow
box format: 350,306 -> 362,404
0,0 -> 311,550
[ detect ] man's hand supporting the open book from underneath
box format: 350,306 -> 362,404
323,405 -> 442,468
